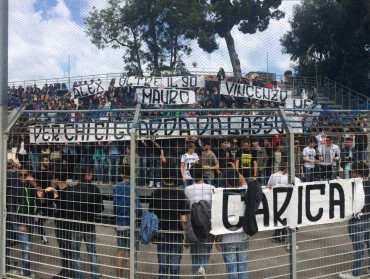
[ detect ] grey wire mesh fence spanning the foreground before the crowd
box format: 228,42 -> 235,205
1,105 -> 369,278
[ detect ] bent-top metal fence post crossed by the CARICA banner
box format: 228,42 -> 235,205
279,107 -> 298,279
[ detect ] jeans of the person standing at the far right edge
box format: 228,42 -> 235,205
348,218 -> 370,276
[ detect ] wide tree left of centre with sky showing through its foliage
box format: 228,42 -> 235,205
85,0 -> 217,75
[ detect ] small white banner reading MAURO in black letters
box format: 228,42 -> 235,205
136,88 -> 196,105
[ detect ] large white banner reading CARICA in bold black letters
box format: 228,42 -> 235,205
211,178 -> 356,235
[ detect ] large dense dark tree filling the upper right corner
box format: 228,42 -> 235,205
281,0 -> 370,93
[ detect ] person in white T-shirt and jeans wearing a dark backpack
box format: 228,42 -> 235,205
185,163 -> 215,278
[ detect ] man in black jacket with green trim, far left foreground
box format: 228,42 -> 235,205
8,163 -> 44,277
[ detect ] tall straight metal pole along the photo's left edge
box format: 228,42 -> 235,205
0,0 -> 9,278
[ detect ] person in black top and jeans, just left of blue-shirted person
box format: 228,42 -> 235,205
71,166 -> 104,279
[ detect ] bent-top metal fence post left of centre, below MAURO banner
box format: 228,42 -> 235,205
129,105 -> 141,279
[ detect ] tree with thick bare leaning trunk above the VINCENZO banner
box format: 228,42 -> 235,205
207,0 -> 284,79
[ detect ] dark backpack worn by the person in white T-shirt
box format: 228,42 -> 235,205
185,200 -> 212,243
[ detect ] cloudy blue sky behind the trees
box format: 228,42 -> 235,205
9,0 -> 299,82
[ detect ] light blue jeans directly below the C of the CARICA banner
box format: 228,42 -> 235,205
222,240 -> 249,279
